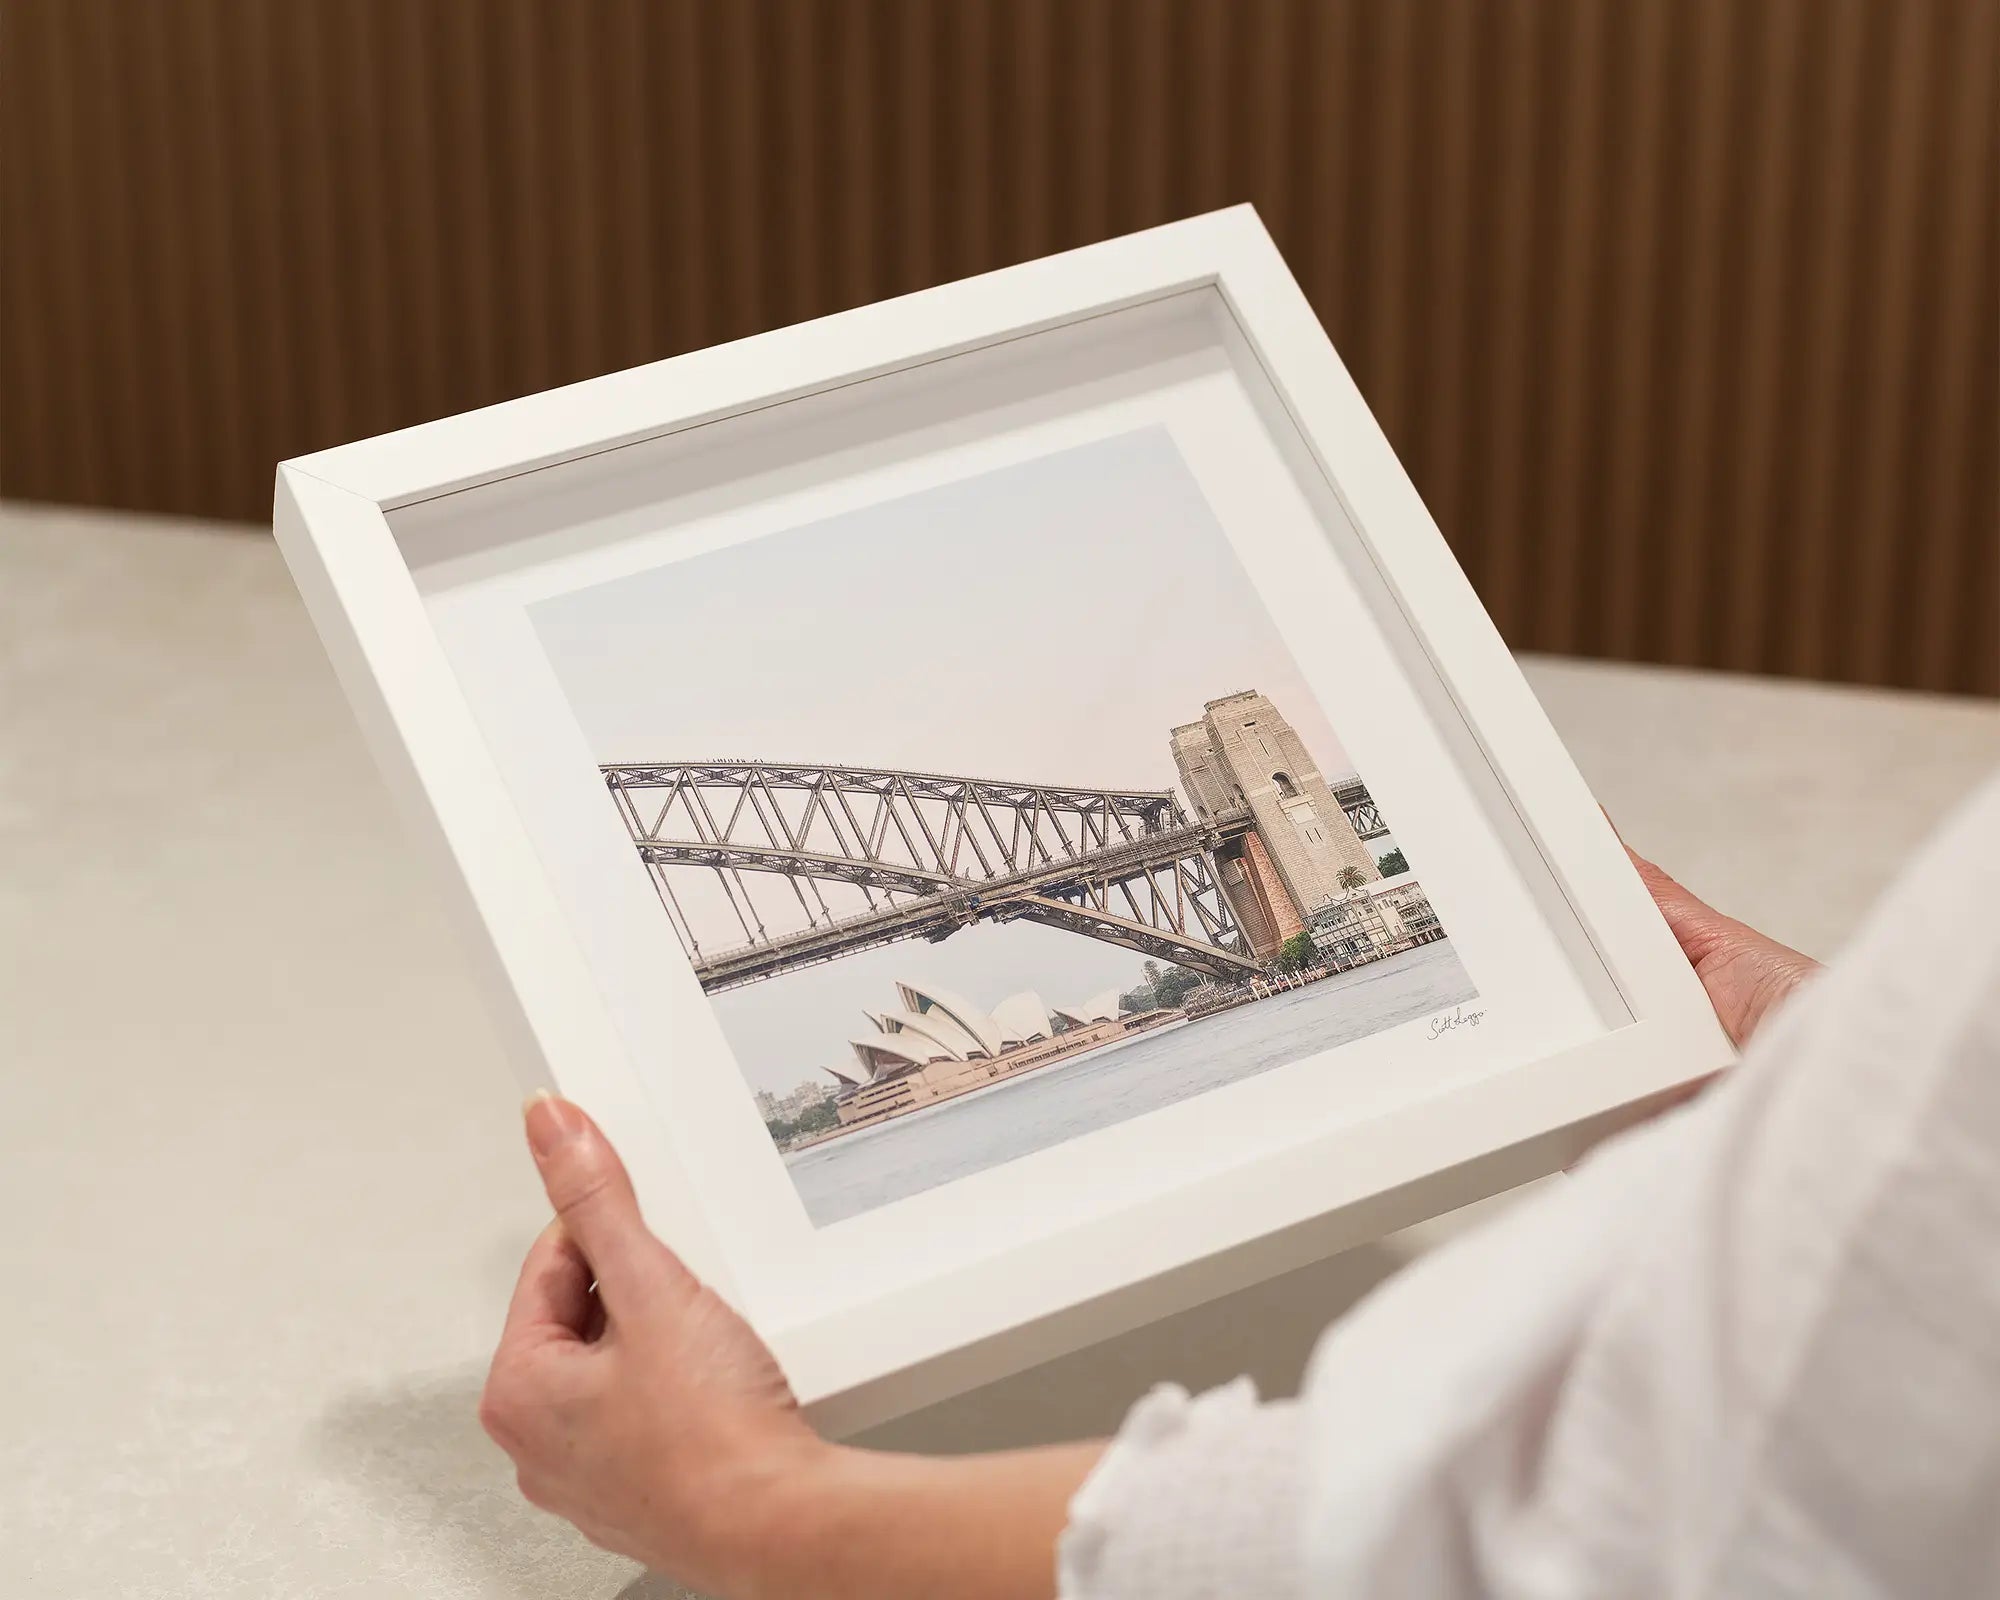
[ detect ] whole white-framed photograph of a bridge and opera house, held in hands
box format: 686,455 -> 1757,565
276,208 -> 1728,1432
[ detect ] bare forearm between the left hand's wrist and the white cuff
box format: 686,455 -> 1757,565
730,1440 -> 1104,1600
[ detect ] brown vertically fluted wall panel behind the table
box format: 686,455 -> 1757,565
0,0 -> 2000,690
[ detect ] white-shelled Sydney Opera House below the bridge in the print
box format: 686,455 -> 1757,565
826,982 -> 1174,1128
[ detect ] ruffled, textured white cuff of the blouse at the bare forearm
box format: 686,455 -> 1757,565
1056,1378 -> 1304,1600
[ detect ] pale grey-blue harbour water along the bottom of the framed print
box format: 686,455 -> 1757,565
786,940 -> 1476,1228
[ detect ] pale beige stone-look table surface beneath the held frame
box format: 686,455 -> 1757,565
0,508 -> 2000,1600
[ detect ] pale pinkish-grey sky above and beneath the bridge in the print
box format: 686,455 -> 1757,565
532,428 -> 1388,1092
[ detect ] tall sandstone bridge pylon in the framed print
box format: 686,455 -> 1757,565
1172,690 -> 1382,960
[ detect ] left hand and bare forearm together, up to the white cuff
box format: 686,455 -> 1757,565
480,1096 -> 1104,1600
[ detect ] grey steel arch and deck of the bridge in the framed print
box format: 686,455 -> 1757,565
602,760 -> 1388,994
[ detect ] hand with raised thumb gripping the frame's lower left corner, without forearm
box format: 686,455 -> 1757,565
480,1094 -> 830,1594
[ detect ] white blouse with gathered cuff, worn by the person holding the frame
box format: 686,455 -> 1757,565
1060,768 -> 2000,1600
